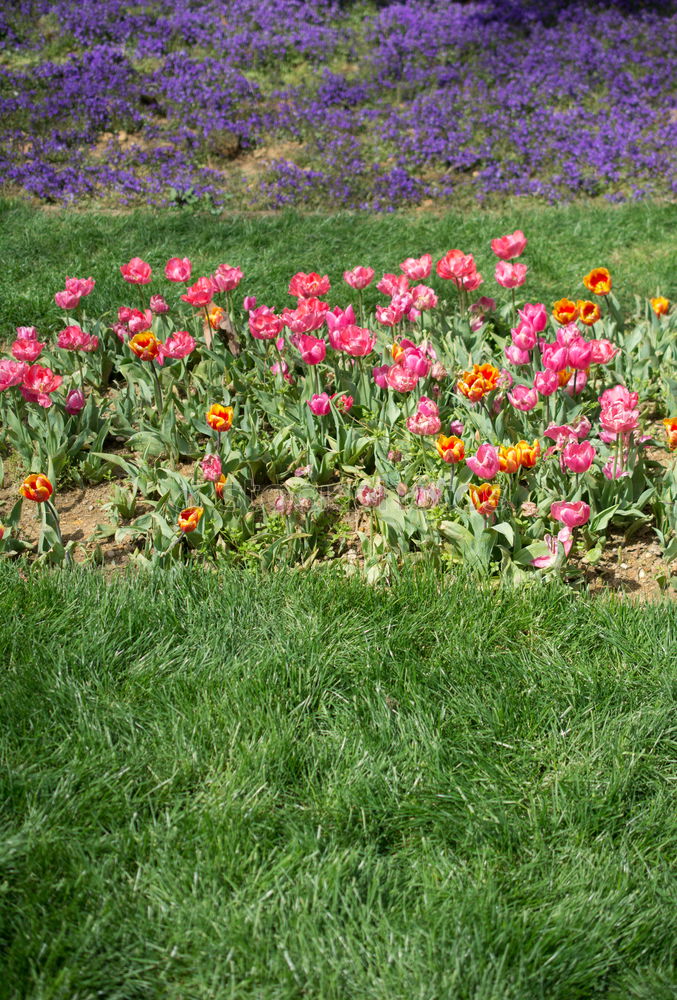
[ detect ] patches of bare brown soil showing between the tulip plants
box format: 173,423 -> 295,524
0,462 -> 674,601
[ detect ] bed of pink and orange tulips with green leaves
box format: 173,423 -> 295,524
0,231 -> 677,579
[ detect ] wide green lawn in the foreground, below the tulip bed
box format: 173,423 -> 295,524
0,564 -> 677,1000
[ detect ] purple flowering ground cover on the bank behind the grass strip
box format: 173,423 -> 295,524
0,0 -> 677,211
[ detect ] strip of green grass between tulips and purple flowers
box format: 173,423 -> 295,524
0,199 -> 677,338
